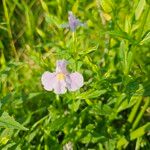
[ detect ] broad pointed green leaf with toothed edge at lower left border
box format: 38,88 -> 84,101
0,112 -> 28,130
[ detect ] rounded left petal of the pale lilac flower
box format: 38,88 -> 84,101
41,71 -> 57,91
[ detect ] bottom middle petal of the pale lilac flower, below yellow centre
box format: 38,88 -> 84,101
54,80 -> 67,94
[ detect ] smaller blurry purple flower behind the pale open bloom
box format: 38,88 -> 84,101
61,11 -> 85,32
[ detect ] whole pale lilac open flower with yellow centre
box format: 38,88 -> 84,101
41,60 -> 84,94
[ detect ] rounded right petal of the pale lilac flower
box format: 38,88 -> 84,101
67,72 -> 84,91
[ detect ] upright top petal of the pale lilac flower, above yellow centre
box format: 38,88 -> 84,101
56,60 -> 67,74
